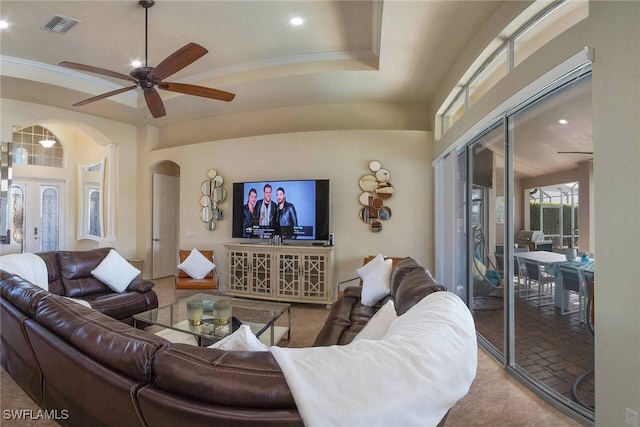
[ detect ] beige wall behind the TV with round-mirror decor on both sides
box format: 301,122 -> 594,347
138,130 -> 434,290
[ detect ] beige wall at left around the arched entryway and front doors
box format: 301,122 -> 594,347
0,99 -> 137,257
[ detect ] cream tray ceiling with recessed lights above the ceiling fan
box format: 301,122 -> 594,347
0,0 -> 501,128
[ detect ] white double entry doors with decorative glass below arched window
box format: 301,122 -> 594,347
9,178 -> 66,252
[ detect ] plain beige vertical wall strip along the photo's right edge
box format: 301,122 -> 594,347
589,1 -> 640,426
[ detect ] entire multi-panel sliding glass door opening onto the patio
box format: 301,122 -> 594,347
436,67 -> 595,424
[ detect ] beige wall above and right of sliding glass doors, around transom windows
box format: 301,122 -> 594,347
431,1 -> 640,426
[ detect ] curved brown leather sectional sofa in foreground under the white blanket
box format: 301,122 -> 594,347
0,260 -> 446,426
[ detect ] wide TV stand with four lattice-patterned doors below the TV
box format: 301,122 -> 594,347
225,243 -> 334,304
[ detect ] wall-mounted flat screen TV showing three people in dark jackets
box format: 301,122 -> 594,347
232,179 -> 329,240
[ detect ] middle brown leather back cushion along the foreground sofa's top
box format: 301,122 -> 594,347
35,294 -> 168,382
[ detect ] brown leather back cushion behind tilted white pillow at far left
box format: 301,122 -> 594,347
58,248 -> 112,298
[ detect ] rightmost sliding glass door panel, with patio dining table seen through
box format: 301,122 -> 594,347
509,70 -> 595,417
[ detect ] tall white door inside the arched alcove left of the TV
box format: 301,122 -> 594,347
152,173 -> 179,279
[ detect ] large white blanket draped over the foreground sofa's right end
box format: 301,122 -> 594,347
269,292 -> 477,427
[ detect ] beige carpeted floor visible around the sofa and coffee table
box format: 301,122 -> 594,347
0,278 -> 580,427
